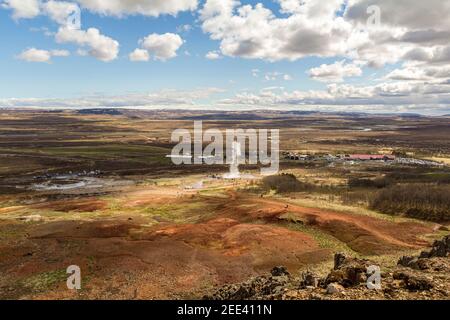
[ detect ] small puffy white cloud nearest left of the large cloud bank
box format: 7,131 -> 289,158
130,33 -> 184,61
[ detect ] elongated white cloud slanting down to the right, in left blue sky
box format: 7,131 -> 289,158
55,27 -> 119,62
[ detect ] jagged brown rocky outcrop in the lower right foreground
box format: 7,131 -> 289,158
204,236 -> 450,300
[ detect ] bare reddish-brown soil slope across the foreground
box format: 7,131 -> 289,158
0,192 -> 432,299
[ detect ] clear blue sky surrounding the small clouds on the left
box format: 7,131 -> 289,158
0,1 -> 330,98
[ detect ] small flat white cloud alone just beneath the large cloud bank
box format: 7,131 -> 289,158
308,60 -> 362,82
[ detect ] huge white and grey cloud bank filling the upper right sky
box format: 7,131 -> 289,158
200,0 -> 450,67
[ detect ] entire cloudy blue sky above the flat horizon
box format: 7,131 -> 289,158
0,0 -> 450,115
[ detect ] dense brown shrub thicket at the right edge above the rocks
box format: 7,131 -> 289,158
370,184 -> 450,222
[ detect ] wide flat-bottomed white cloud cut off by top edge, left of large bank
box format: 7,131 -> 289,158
77,0 -> 197,17
